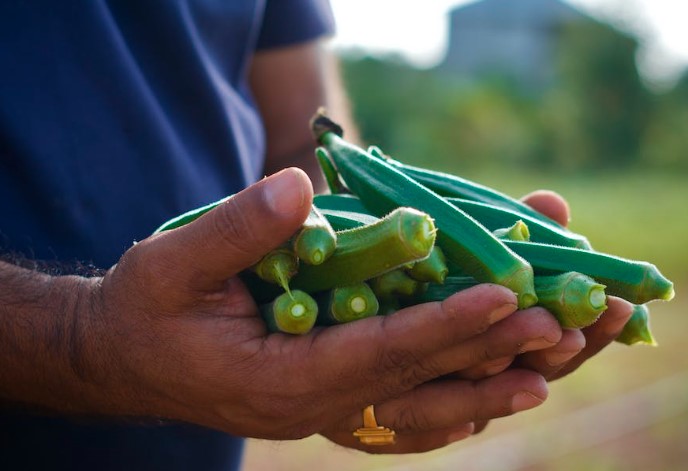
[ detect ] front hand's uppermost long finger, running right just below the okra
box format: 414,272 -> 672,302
302,284 -> 517,408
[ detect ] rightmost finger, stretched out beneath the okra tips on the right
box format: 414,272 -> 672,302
550,296 -> 633,379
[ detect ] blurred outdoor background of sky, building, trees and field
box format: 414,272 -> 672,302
245,0 -> 688,471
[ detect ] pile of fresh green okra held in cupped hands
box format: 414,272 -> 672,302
156,113 -> 674,345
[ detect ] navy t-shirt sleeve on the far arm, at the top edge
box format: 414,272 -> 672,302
257,0 -> 335,49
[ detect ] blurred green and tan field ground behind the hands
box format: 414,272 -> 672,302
244,172 -> 688,471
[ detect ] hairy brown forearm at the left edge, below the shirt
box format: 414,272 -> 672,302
0,261 -> 125,415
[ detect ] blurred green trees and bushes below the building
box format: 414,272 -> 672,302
343,17 -> 688,173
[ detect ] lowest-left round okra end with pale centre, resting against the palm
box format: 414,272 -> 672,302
260,290 -> 318,334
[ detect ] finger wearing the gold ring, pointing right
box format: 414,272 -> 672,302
337,369 -> 548,435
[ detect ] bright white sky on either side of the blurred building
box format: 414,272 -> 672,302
330,0 -> 688,86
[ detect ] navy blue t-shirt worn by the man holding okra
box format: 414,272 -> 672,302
0,0 -> 333,471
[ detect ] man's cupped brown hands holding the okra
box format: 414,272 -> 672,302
74,169 -> 630,453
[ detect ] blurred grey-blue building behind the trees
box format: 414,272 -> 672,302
438,0 -> 593,89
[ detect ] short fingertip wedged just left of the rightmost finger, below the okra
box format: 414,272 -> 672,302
516,329 -> 586,378
